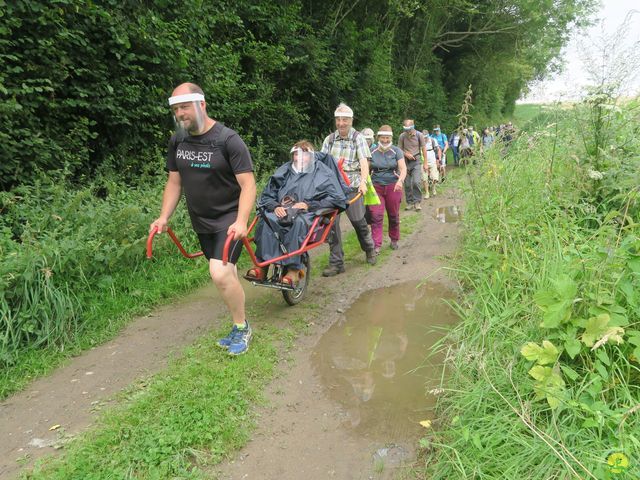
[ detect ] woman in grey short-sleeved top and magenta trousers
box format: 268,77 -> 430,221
367,125 -> 407,254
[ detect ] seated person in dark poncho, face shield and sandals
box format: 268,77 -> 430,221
250,140 -> 347,285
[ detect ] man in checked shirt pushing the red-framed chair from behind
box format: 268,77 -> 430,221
322,103 -> 376,277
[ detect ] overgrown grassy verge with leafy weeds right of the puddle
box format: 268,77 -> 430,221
418,103 -> 640,480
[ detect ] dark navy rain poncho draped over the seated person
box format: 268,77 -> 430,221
255,153 -> 347,270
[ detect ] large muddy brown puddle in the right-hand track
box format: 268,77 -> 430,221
312,282 -> 456,440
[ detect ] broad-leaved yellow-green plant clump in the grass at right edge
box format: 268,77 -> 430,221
520,235 -> 640,424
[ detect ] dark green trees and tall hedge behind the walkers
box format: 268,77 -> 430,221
0,0 -> 593,189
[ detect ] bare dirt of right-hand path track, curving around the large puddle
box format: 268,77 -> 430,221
211,191 -> 462,480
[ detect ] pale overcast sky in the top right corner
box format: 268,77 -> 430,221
521,0 -> 640,102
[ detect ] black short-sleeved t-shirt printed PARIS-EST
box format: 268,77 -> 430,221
166,122 -> 253,233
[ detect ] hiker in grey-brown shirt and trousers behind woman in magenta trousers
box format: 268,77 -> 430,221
398,118 -> 427,210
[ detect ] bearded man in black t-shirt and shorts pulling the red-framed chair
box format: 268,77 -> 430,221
149,83 -> 256,355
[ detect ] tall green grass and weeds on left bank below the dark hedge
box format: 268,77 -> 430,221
0,173 -> 199,366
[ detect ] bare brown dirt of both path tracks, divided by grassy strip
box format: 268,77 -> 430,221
0,189 -> 460,480
